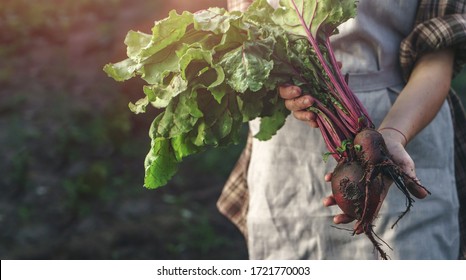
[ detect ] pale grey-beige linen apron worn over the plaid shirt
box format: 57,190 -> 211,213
247,0 -> 459,259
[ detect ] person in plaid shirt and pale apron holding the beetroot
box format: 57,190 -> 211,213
218,0 -> 466,259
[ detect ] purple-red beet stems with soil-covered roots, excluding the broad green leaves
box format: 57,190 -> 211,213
276,0 -> 430,259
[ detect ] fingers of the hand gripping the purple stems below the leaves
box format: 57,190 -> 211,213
278,85 -> 319,128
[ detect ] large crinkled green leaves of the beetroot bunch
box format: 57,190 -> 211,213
104,0 -> 355,188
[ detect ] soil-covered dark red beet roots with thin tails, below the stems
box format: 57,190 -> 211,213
331,128 -> 425,259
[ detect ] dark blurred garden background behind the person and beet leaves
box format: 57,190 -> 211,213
0,0 -> 466,259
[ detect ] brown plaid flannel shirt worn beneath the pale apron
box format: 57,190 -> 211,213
217,0 -> 466,259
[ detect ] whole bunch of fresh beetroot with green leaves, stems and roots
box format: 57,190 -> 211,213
104,0 -> 430,258
